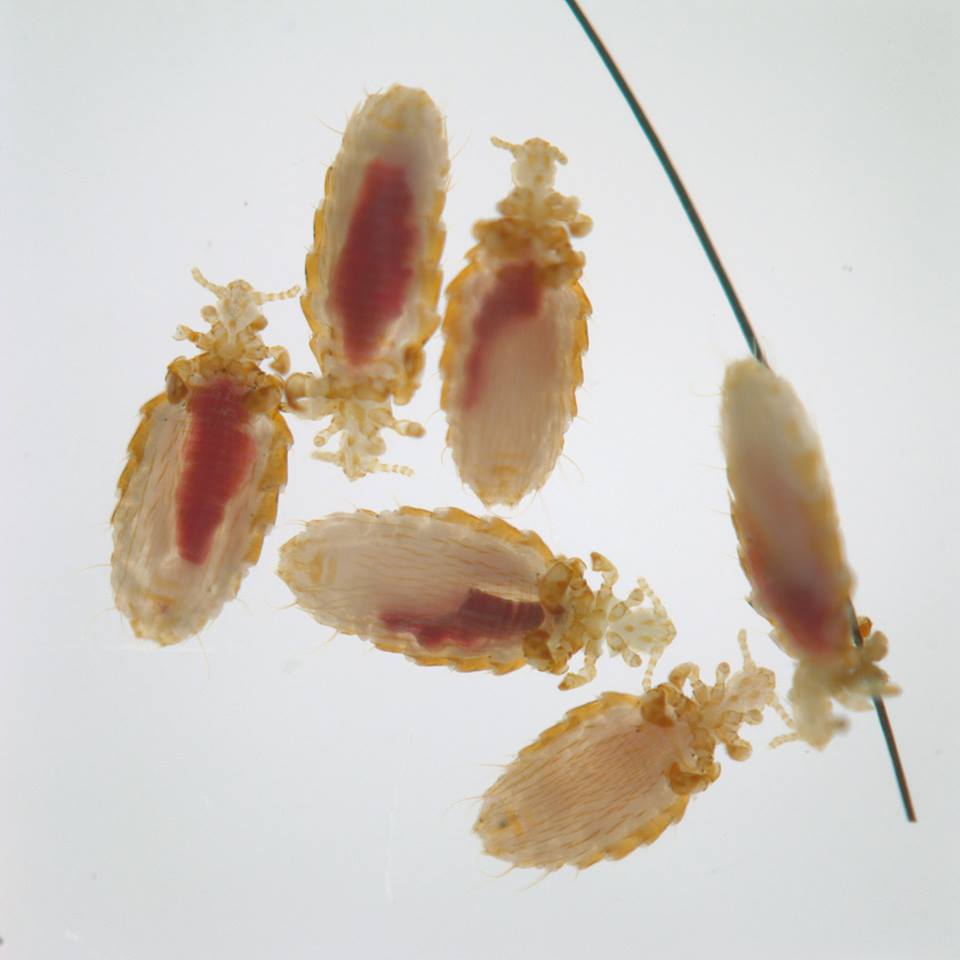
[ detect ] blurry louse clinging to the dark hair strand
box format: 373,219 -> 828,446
721,359 -> 897,747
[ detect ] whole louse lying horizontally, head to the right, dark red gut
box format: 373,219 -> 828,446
278,507 -> 675,689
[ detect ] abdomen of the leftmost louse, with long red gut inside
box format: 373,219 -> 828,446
112,373 -> 292,644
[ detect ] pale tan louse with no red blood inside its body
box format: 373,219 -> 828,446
474,632 -> 776,870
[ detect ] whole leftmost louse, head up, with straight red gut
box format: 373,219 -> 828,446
111,270 -> 300,644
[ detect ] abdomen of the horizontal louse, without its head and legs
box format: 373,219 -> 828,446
279,508 -> 554,671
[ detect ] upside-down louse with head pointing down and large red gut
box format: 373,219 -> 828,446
287,85 -> 450,479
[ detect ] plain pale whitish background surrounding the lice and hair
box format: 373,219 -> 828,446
0,0 -> 960,960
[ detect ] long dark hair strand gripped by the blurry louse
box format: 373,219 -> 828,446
564,0 -> 917,823
